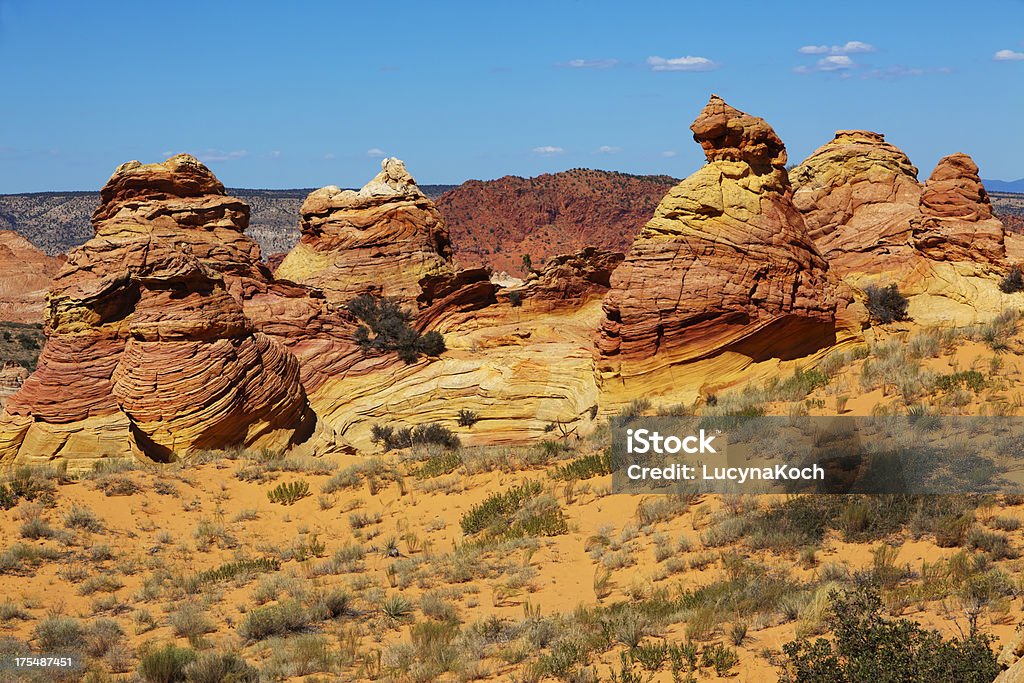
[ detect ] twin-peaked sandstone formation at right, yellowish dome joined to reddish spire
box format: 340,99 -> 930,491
790,130 -> 1013,325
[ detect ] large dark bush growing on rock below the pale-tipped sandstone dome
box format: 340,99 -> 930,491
348,294 -> 445,362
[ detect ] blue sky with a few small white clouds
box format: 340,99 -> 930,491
0,0 -> 1024,193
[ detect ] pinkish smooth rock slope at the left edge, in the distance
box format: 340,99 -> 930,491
0,230 -> 62,323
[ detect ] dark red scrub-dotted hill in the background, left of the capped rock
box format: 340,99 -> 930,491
437,169 -> 679,276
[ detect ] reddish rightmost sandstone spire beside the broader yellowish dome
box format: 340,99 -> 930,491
913,154 -> 1007,263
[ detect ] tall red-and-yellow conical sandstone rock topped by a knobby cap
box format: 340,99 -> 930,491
598,96 -> 838,405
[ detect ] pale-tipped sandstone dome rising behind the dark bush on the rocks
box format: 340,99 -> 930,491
275,159 -> 453,304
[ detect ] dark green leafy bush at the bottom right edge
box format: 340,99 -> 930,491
781,588 -> 999,683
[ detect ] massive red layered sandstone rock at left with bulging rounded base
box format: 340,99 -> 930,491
0,155 -> 327,471
